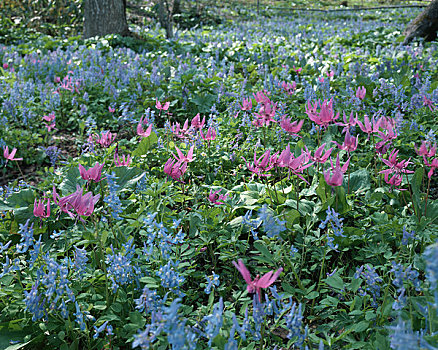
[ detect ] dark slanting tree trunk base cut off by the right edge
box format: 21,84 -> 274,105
403,0 -> 438,45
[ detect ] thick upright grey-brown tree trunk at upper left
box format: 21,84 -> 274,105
83,0 -> 129,38
